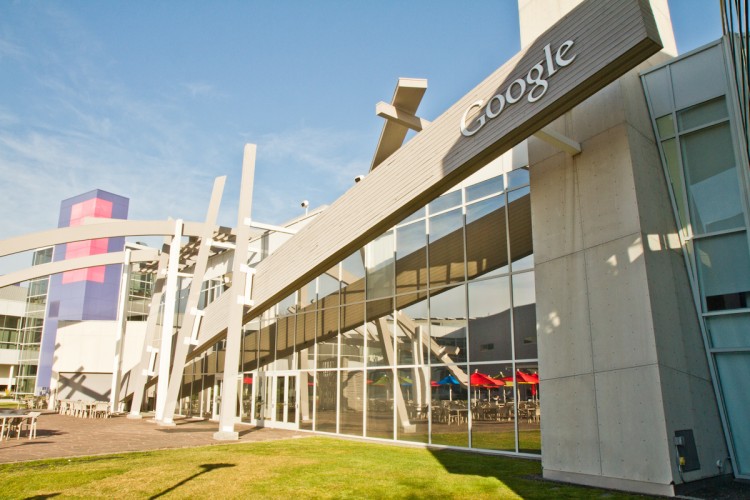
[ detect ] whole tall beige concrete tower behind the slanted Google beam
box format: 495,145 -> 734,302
519,0 -> 726,495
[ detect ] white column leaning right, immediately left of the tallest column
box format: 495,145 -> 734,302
159,176 -> 227,425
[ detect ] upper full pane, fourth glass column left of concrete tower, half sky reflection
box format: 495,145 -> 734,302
396,220 -> 427,293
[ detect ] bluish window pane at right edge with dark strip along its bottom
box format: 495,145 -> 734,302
695,231 -> 750,311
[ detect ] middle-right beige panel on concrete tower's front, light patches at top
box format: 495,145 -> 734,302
588,235 -> 657,371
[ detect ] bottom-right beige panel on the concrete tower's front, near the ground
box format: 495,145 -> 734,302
595,364 -> 672,485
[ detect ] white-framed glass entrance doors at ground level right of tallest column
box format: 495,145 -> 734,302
253,371 -> 299,429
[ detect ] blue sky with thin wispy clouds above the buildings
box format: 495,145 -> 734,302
0,0 -> 721,273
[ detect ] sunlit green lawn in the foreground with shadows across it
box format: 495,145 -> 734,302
0,437 -> 648,499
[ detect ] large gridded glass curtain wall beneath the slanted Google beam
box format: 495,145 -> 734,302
243,160 -> 541,454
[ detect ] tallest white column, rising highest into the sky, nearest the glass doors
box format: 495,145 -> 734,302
214,144 -> 256,441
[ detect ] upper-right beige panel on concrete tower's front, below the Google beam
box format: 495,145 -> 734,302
573,123 -> 640,248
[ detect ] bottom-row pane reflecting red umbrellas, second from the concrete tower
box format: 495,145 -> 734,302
469,364 -> 520,452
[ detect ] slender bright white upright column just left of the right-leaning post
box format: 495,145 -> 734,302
155,219 -> 182,420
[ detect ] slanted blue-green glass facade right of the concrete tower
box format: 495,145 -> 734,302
642,41 -> 750,478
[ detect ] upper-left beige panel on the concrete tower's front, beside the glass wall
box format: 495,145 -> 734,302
529,152 -> 583,266
